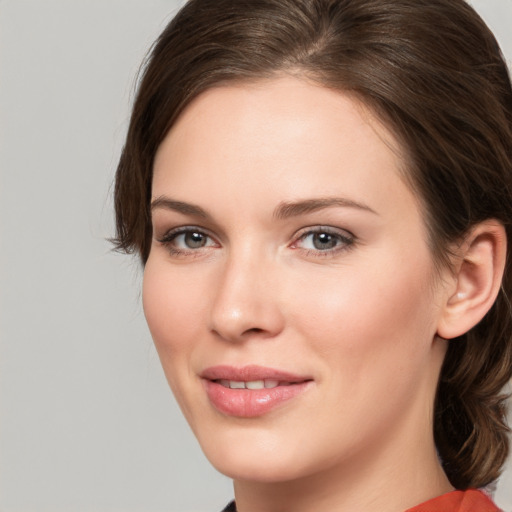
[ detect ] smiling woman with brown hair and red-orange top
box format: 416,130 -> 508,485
115,0 -> 512,512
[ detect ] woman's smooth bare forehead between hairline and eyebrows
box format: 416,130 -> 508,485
153,77 -> 420,223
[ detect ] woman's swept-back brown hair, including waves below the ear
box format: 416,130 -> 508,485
115,0 -> 512,489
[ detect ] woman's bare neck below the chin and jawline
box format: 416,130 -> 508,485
234,434 -> 453,512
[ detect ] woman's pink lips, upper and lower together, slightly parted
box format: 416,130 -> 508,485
200,365 -> 313,418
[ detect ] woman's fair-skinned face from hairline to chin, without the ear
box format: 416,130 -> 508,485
143,77 -> 444,481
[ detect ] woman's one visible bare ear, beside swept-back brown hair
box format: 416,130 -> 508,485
437,220 -> 507,339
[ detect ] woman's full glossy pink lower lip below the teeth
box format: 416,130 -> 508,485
203,380 -> 311,418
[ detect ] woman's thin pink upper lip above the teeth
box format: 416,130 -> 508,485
200,365 -> 312,383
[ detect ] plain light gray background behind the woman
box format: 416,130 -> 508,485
0,0 -> 512,512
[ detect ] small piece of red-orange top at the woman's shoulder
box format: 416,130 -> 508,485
405,489 -> 500,512
